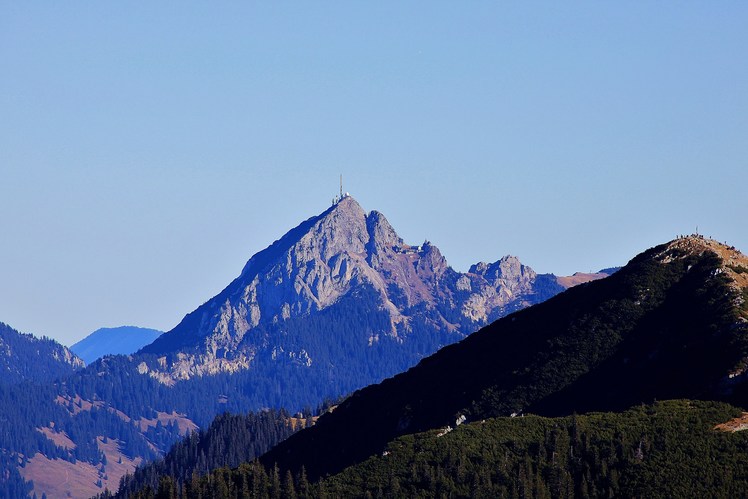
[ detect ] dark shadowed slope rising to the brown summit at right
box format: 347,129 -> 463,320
262,236 -> 748,478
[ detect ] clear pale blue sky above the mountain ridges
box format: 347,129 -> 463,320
0,0 -> 748,344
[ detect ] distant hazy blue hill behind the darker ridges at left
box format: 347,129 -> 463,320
70,326 -> 163,364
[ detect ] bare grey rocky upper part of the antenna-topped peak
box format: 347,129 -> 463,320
144,197 -> 560,379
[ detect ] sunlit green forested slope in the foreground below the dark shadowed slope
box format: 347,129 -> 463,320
165,400 -> 748,499
